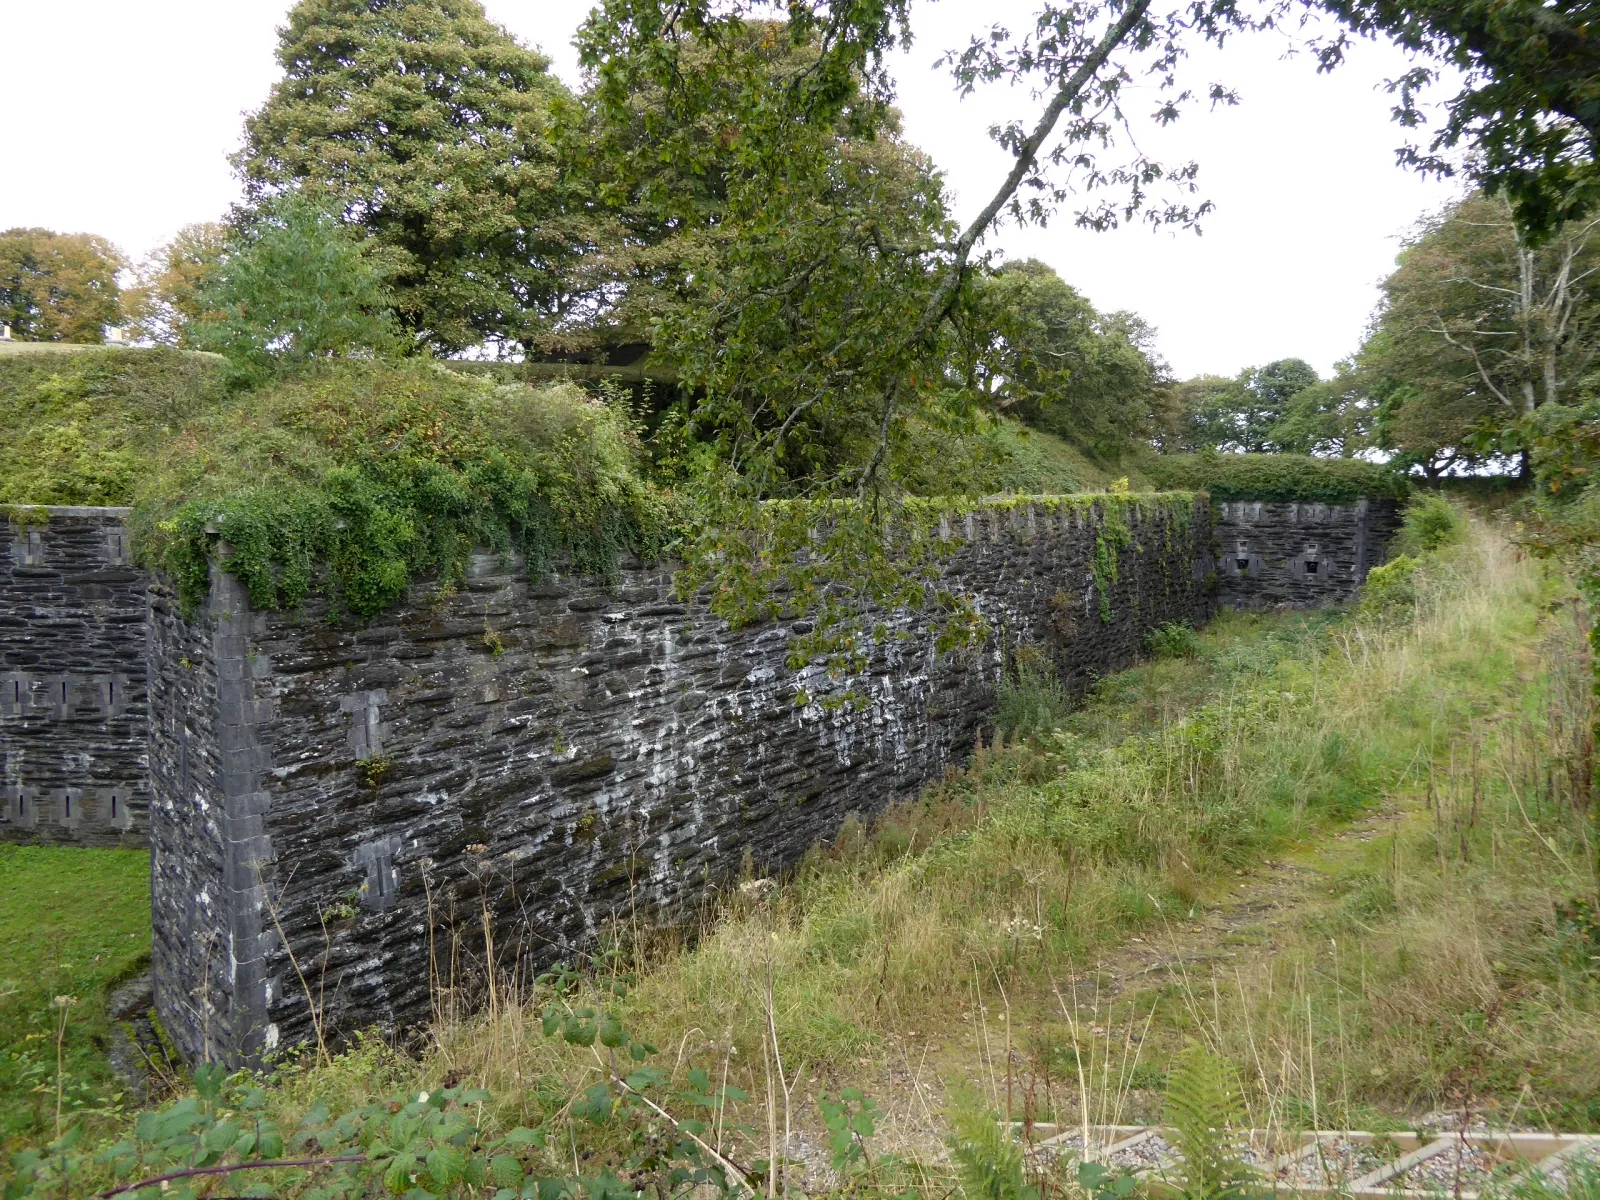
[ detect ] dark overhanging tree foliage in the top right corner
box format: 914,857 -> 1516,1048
1318,0 -> 1600,242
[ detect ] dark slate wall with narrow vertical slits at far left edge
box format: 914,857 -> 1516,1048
0,507 -> 149,846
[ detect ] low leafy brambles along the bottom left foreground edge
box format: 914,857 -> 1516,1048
3,998 -> 761,1200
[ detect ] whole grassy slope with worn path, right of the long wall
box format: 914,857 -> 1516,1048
246,508 -> 1600,1150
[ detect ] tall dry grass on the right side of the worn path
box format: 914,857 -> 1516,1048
1139,538 -> 1600,1130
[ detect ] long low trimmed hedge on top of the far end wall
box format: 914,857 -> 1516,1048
1144,453 -> 1410,504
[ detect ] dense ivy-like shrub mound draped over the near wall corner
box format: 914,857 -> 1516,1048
134,362 -> 670,616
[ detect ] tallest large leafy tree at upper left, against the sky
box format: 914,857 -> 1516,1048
235,0 -> 578,352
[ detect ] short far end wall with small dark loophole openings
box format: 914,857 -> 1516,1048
1213,499 -> 1400,610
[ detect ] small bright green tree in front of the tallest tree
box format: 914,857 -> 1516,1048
184,194 -> 403,381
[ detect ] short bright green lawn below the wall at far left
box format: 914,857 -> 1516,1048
0,846 -> 150,1144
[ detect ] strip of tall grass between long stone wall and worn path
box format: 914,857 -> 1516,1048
576,531 -> 1544,1062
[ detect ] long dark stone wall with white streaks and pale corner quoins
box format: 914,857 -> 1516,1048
150,496 -> 1211,1062
